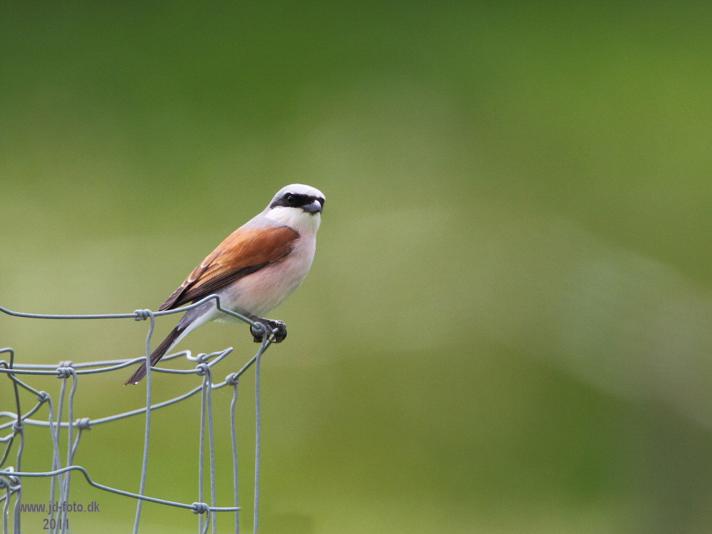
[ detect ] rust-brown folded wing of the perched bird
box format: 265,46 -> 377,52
158,226 -> 299,311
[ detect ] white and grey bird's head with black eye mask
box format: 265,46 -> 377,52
265,184 -> 326,232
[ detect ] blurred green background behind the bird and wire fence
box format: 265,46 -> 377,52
0,2 -> 712,534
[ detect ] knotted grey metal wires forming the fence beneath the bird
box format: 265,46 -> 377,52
0,295 -> 275,534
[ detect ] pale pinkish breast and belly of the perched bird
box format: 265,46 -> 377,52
220,237 -> 316,316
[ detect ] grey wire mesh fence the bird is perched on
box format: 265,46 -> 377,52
0,295 -> 276,534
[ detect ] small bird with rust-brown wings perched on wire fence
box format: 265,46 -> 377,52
126,184 -> 326,385
